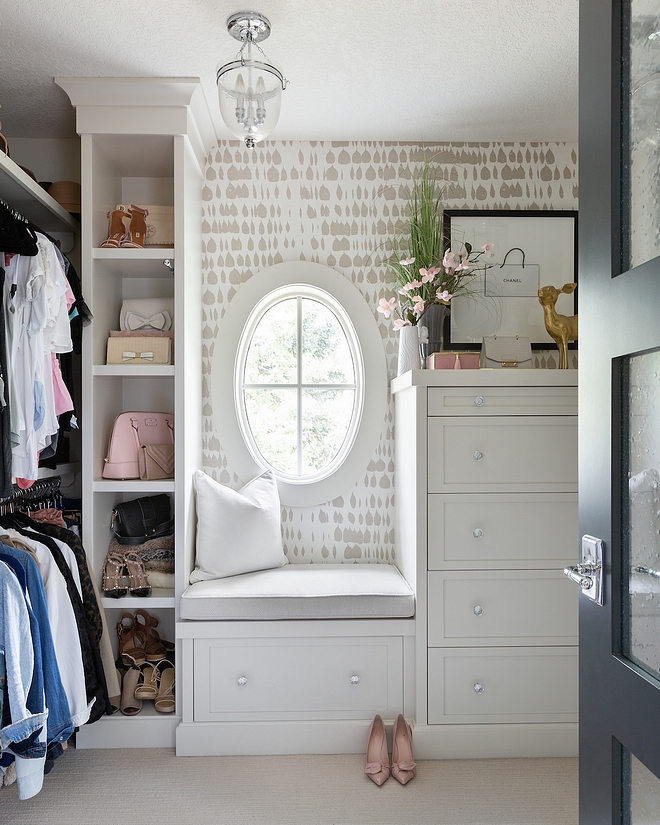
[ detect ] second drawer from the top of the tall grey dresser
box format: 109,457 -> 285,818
428,416 -> 577,493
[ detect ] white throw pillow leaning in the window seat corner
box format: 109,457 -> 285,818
190,470 -> 287,584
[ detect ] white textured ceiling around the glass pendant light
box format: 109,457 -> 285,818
0,0 -> 578,142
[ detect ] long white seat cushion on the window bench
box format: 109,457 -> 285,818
181,564 -> 415,621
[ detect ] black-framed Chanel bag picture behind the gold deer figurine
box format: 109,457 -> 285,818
444,209 -> 578,350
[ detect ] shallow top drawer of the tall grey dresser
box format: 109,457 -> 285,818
427,387 -> 577,416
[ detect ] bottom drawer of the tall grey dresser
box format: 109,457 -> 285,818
428,647 -> 578,725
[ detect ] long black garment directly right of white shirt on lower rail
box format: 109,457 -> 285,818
0,514 -> 112,724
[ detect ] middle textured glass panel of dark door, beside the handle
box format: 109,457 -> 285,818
621,351 -> 660,676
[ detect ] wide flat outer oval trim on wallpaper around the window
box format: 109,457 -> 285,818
210,261 -> 387,507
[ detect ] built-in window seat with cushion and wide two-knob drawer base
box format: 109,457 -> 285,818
176,564 -> 415,756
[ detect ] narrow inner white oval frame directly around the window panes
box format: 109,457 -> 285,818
234,283 -> 364,484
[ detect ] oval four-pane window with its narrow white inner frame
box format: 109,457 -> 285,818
235,284 -> 363,483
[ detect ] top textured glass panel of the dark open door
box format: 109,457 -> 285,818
622,0 -> 660,270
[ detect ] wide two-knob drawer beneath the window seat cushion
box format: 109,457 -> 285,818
194,637 -> 403,722
